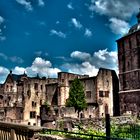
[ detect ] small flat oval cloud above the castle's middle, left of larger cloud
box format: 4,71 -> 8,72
70,51 -> 91,60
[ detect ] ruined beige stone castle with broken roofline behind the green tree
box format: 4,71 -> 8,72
0,68 -> 119,125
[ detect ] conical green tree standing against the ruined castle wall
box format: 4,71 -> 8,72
66,78 -> 87,117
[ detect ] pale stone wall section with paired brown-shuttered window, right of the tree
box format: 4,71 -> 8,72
96,69 -> 113,117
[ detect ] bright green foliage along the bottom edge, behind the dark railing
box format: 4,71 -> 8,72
41,124 -> 140,140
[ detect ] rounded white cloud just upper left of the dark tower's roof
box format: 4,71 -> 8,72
109,18 -> 130,35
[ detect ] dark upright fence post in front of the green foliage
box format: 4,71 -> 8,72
105,114 -> 110,140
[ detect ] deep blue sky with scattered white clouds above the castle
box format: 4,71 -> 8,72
0,0 -> 140,82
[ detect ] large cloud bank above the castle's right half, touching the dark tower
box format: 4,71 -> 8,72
62,49 -> 118,76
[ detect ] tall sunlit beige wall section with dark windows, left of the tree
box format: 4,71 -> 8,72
24,78 -> 46,125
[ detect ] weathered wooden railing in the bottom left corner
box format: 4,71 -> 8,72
0,121 -> 42,140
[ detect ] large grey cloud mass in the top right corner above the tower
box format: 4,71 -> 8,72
89,0 -> 140,34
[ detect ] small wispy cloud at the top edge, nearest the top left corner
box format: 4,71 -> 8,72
16,0 -> 33,11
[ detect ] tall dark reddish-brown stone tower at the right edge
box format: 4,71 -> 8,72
117,9 -> 140,115
